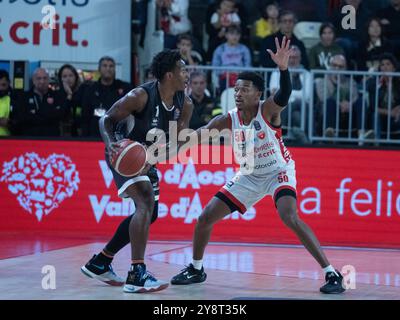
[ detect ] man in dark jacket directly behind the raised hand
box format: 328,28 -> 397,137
260,11 -> 309,69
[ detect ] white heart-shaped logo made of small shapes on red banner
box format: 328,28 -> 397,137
0,153 -> 80,221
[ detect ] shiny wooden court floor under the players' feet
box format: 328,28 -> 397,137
0,242 -> 400,300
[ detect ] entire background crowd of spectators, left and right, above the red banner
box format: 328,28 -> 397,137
0,0 -> 400,143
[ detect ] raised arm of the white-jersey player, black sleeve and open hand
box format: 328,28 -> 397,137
262,37 -> 292,126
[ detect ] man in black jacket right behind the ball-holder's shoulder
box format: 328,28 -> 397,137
82,57 -> 132,138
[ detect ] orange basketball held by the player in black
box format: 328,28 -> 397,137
111,139 -> 147,177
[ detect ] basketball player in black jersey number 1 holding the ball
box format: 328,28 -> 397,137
81,50 -> 193,293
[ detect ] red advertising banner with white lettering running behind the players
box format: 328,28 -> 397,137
0,140 -> 400,248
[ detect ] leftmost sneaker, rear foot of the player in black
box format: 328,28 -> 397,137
81,255 -> 125,286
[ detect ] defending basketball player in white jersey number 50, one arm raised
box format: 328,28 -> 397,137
171,37 -> 345,293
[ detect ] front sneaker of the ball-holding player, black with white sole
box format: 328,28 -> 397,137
124,264 -> 169,293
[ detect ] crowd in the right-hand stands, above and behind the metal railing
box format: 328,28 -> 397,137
151,0 -> 400,142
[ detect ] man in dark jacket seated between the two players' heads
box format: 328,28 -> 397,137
189,71 -> 221,130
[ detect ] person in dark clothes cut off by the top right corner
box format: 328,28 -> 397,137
377,0 -> 400,56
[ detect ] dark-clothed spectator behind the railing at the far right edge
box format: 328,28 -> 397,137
367,53 -> 400,139
